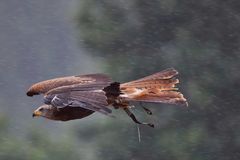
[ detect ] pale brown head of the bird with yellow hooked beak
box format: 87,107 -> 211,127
32,105 -> 57,119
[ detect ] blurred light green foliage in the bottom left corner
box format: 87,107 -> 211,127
0,116 -> 80,160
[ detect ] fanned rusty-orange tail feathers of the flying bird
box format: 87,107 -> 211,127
120,68 -> 188,106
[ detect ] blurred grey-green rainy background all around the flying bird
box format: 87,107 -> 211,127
0,0 -> 240,160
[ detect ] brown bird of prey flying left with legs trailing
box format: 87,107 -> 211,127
27,68 -> 187,127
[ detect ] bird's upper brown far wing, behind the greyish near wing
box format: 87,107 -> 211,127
27,74 -> 111,96
